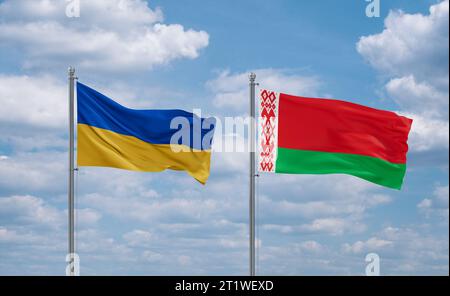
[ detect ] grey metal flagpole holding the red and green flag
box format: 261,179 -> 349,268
249,73 -> 256,276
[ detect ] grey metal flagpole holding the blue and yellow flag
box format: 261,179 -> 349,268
68,67 -> 76,276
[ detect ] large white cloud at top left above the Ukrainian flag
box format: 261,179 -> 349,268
0,0 -> 209,71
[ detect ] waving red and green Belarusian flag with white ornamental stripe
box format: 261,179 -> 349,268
259,90 -> 412,189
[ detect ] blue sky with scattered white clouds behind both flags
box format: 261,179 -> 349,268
0,0 -> 449,275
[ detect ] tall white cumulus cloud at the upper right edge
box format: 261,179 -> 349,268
357,0 -> 449,152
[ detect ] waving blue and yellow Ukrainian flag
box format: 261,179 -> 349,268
77,82 -> 215,184
